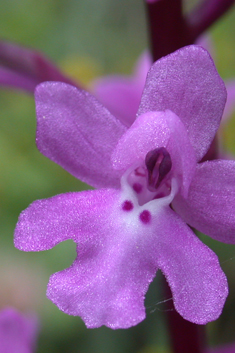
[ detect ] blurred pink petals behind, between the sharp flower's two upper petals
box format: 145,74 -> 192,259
93,52 -> 151,126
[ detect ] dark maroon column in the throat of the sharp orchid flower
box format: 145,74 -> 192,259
145,147 -> 172,191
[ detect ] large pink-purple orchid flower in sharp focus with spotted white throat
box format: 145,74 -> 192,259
15,46 -> 235,329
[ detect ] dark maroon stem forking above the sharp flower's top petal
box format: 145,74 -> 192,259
146,0 -> 235,61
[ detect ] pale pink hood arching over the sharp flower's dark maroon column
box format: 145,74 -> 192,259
112,110 -> 196,194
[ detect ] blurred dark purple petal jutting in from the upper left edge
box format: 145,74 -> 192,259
0,41 -> 75,93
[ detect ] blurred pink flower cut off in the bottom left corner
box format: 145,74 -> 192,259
0,308 -> 38,353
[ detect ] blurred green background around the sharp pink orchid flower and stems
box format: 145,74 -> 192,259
0,0 -> 235,353
